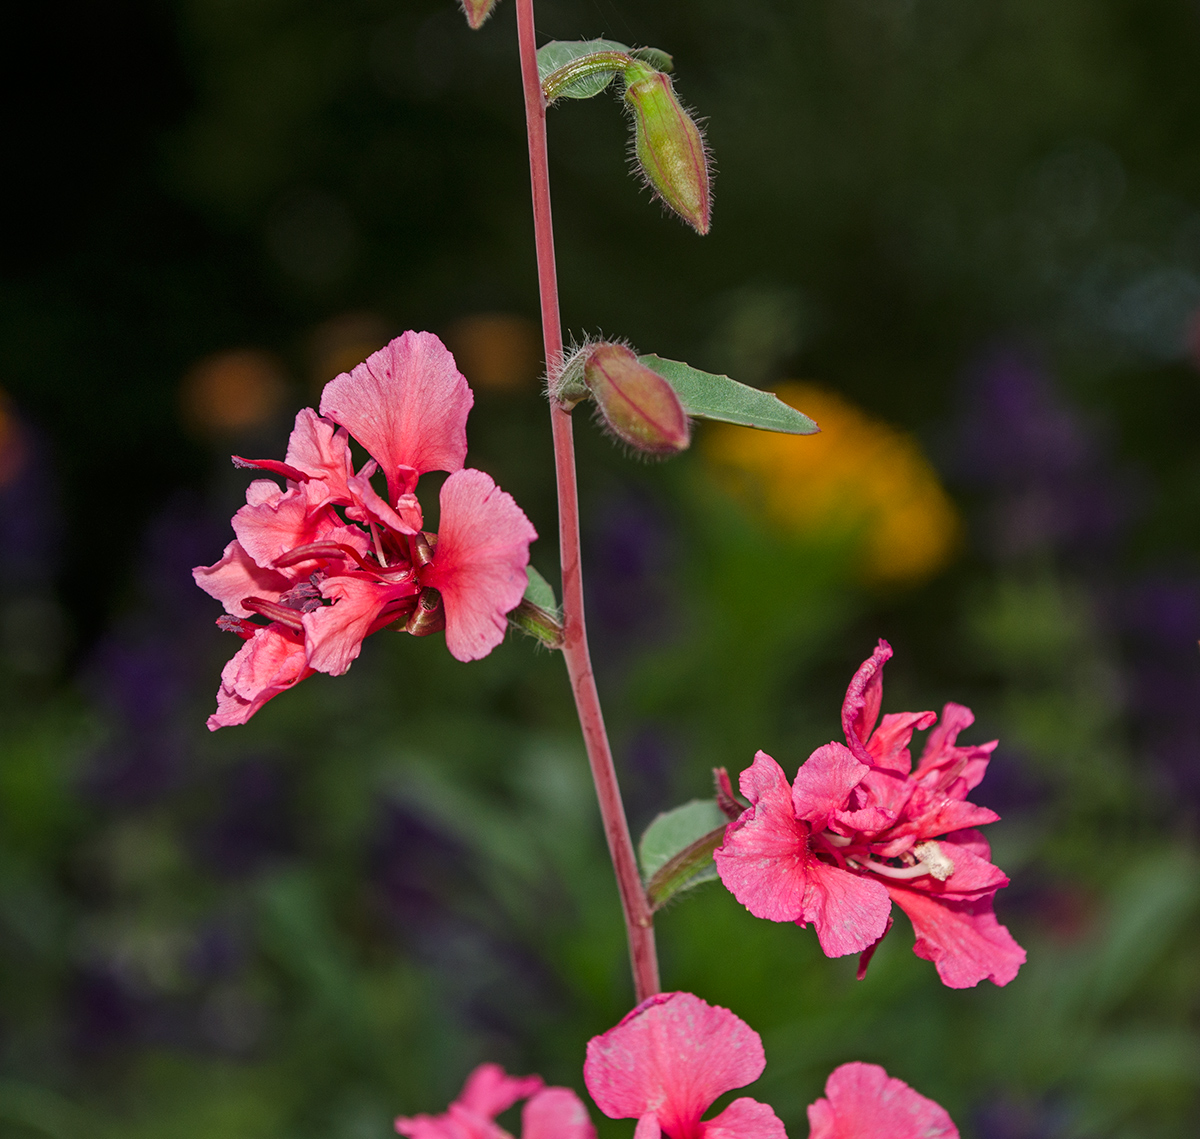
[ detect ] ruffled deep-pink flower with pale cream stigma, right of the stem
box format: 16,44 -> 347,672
714,641 -> 1025,989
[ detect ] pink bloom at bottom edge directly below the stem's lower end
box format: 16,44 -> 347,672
583,993 -> 786,1139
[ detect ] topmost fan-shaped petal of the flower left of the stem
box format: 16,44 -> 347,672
320,332 -> 474,502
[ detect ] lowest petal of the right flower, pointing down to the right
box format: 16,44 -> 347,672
884,882 -> 1025,989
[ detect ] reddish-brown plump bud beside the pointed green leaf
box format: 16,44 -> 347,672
583,343 -> 691,455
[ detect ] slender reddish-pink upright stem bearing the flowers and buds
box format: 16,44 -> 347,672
517,0 -> 659,1001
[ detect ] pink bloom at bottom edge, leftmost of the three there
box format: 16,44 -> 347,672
396,1063 -> 595,1139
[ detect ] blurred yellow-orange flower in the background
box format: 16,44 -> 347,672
702,383 -> 959,583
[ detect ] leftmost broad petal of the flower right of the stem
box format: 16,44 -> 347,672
713,751 -> 811,922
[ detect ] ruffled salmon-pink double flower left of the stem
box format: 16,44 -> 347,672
192,332 -> 538,730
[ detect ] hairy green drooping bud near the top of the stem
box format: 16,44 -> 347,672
625,64 -> 713,234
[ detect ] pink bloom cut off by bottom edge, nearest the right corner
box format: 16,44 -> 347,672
809,1063 -> 959,1139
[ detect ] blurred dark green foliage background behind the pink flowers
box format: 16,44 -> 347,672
0,0 -> 1200,1139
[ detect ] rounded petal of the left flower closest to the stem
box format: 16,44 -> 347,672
421,470 -> 538,660
